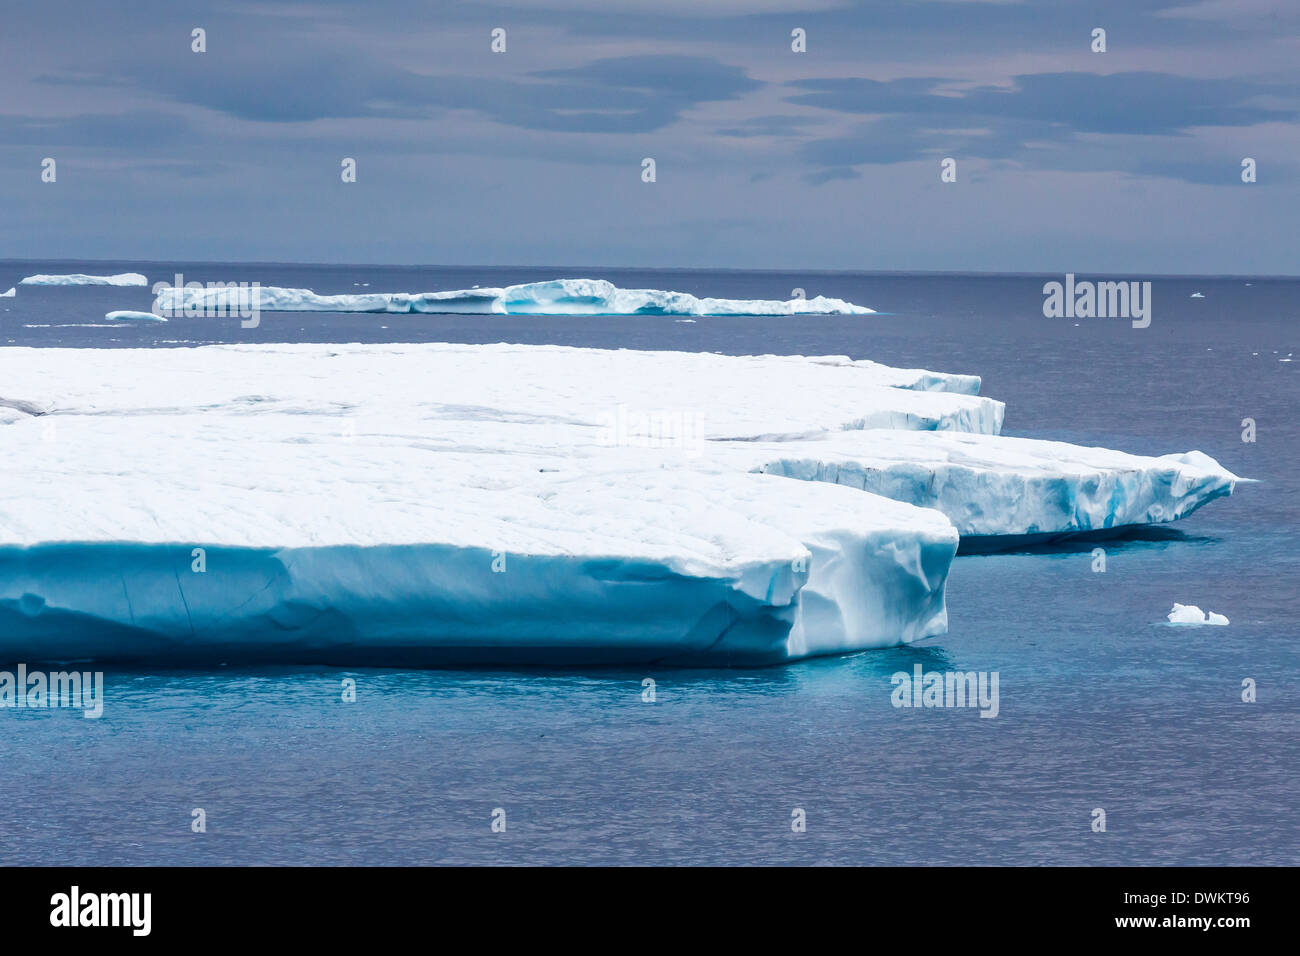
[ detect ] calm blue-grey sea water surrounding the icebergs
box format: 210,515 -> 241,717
0,261 -> 1300,865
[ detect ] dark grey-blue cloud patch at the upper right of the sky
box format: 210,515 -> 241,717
790,73 -> 1297,183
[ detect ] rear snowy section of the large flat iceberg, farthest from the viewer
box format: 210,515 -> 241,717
0,343 -> 1004,440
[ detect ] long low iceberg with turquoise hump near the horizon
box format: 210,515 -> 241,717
157,278 -> 874,316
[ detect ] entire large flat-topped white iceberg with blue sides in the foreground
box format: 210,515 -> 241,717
0,345 -> 1235,663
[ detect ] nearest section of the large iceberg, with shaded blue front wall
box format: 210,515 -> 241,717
0,410 -> 957,665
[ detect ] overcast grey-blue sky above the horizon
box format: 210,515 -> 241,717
0,0 -> 1300,276
